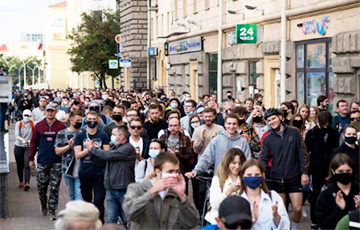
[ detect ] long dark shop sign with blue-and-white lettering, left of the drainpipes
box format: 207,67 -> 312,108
169,36 -> 203,55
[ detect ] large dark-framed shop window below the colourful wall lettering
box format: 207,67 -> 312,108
295,38 -> 336,110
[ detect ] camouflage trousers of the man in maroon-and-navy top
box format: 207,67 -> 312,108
36,163 -> 62,212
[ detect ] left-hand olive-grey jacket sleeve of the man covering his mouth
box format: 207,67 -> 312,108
122,183 -> 154,222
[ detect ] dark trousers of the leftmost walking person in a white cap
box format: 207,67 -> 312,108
14,145 -> 30,183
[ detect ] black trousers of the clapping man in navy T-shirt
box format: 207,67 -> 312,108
80,175 -> 106,223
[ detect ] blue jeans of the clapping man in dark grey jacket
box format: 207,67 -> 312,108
106,189 -> 127,228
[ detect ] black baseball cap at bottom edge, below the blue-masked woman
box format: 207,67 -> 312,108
219,195 -> 252,229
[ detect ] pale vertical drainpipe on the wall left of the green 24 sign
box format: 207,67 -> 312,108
217,0 -> 223,104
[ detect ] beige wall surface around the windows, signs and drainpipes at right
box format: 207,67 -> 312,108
150,0 -> 360,107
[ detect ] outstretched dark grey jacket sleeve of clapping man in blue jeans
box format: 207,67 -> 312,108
90,145 -> 135,160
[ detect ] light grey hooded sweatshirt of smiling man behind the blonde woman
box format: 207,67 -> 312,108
193,130 -> 251,174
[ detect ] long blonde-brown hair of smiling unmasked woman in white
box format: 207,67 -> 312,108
216,148 -> 246,191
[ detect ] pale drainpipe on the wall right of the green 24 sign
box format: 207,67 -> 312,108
280,0 -> 287,103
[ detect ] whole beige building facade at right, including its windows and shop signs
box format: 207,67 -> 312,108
149,0 -> 360,107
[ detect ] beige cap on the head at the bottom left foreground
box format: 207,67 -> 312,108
58,200 -> 102,229
